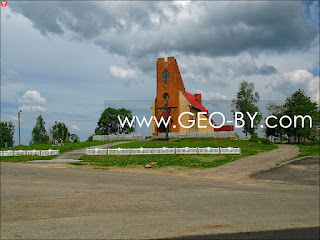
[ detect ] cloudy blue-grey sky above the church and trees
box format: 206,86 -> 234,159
1,1 -> 319,144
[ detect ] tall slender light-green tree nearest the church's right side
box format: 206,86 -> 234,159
231,81 -> 262,136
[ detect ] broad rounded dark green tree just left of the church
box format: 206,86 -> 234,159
95,107 -> 134,135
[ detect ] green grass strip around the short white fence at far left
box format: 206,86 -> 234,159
0,141 -> 114,162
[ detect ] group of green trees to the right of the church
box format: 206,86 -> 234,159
232,81 -> 320,143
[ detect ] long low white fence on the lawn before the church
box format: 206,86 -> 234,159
86,147 -> 241,155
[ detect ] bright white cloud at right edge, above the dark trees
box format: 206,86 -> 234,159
283,70 -> 320,103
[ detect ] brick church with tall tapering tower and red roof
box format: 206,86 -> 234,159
151,57 -> 214,135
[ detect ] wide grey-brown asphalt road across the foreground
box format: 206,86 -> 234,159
1,156 -> 319,239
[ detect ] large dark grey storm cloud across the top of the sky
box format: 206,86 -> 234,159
10,1 -> 317,71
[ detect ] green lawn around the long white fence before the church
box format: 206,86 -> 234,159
80,138 -> 277,168
